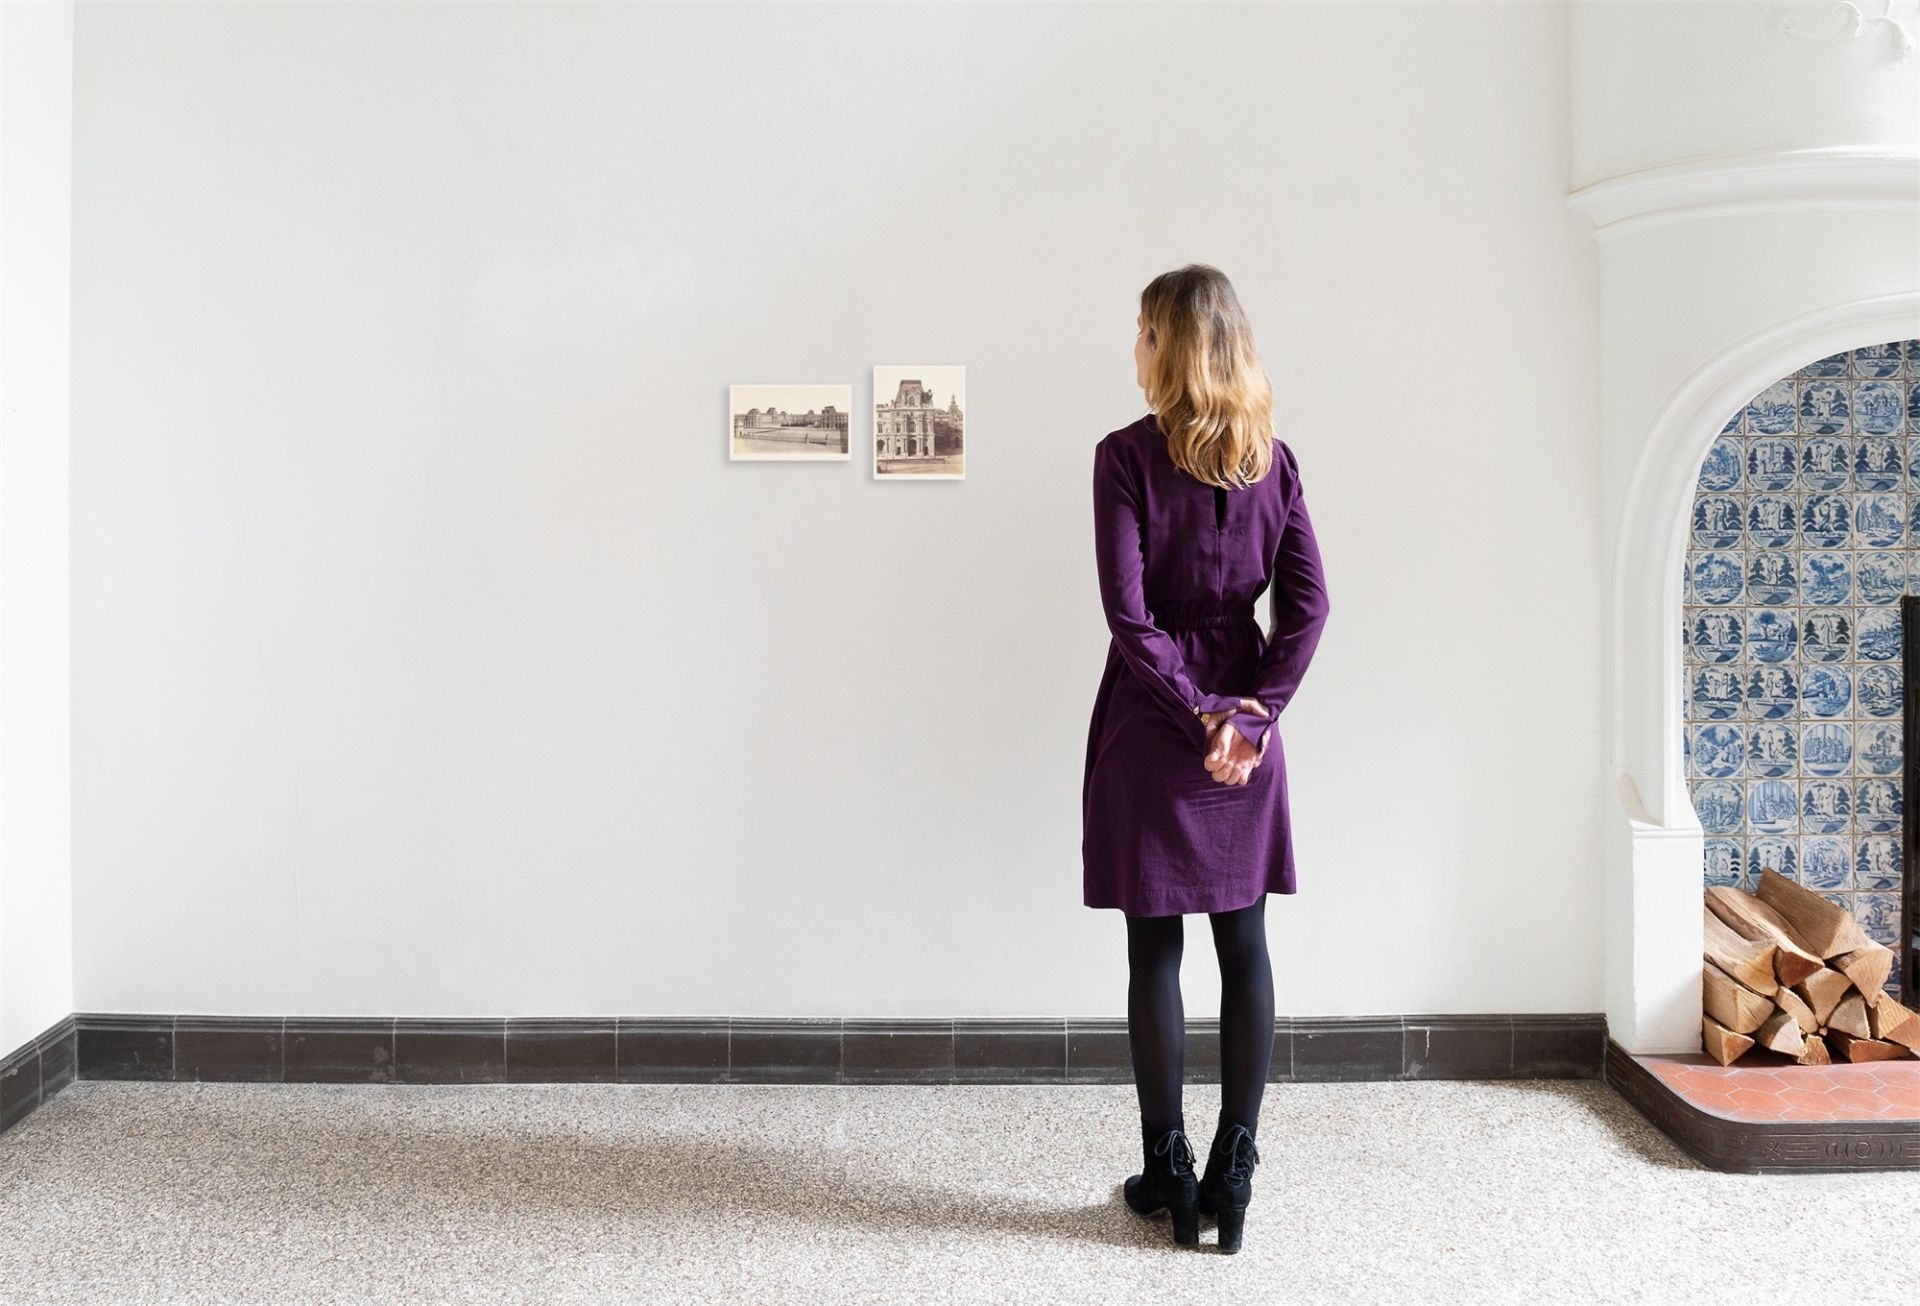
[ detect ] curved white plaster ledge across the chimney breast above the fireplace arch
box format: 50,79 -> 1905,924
1567,146 -> 1920,240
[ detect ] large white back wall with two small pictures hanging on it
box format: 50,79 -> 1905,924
73,4 -> 1601,1016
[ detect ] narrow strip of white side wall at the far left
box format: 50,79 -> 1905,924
0,4 -> 73,1056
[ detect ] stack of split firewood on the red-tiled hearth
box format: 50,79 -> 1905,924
1701,868 -> 1920,1066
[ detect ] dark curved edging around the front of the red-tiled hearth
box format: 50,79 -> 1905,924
1605,1039 -> 1920,1173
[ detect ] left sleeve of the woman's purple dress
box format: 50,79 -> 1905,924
1092,442 -> 1240,753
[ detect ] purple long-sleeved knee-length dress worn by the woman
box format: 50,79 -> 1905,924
1081,413 -> 1327,916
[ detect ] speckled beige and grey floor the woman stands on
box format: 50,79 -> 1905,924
0,1079 -> 1920,1306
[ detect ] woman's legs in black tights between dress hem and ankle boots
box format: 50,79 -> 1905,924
1127,893 -> 1273,1129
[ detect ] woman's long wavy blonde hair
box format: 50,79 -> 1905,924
1140,263 -> 1273,490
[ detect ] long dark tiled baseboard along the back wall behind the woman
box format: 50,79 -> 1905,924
37,1012 -> 1607,1083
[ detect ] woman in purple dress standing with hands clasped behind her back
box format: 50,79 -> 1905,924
1081,263 -> 1327,1252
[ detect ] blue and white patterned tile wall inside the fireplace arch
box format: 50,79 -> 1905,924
1684,340 -> 1920,995
